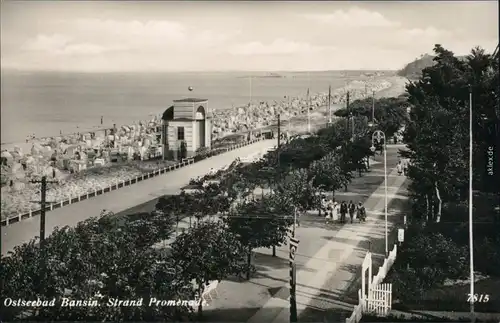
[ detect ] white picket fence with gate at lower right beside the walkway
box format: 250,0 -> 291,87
345,244 -> 398,323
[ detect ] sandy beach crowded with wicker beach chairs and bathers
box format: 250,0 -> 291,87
1,77 -> 406,219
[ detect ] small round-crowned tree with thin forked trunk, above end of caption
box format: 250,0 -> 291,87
171,221 -> 245,316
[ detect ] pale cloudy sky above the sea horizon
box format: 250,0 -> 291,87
1,1 -> 499,72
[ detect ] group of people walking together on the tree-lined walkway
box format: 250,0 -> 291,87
321,197 -> 366,224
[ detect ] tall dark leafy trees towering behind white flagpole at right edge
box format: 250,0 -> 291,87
404,45 -> 498,221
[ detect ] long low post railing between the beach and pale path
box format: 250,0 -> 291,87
2,138 -> 262,226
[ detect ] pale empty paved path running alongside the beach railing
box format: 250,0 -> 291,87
1,140 -> 276,255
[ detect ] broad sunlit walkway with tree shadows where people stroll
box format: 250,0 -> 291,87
199,147 -> 406,323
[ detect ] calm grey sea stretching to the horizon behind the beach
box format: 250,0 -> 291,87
1,70 -> 386,145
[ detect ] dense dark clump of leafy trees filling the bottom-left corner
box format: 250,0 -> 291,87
1,215 -> 192,321
